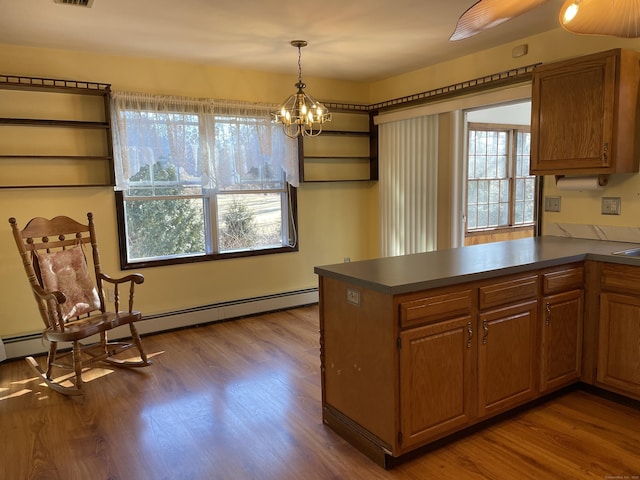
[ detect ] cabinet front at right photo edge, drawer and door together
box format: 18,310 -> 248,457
596,264 -> 640,399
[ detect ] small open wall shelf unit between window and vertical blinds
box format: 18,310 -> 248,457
298,110 -> 378,182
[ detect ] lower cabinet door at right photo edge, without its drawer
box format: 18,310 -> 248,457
597,293 -> 640,398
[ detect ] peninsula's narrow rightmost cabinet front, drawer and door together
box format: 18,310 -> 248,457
539,266 -> 584,393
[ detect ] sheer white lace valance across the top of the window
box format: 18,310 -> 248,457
111,91 -> 299,189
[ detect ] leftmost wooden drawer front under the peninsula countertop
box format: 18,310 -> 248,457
400,290 -> 473,328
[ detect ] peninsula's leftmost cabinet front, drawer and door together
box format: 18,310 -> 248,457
396,287 -> 477,451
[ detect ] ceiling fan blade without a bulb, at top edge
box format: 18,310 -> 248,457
449,0 -> 549,42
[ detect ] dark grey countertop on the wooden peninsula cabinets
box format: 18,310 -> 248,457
314,236 -> 640,295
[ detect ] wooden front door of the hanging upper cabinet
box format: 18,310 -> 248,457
531,52 -> 615,174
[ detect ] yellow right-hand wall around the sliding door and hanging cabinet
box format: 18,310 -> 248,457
371,28 -> 640,242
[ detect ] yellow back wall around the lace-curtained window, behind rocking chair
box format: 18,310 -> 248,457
0,45 -> 378,337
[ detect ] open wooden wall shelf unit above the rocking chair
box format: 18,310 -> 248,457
0,75 -> 114,188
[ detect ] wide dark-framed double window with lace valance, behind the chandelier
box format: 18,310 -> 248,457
112,92 -> 298,268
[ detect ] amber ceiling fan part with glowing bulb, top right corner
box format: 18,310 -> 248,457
559,0 -> 640,38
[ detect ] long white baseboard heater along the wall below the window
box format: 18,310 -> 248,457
0,288 -> 318,361
